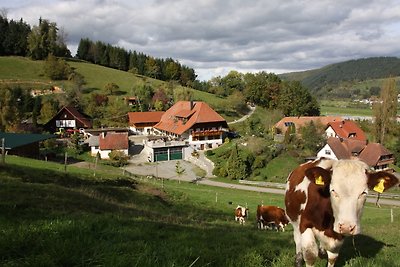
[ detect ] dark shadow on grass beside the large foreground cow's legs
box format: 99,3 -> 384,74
336,235 -> 395,266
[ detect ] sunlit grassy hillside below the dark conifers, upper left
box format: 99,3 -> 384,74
0,57 -> 233,120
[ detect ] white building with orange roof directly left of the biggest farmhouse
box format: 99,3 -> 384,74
128,111 -> 165,135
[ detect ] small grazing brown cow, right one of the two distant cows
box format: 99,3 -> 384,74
257,205 -> 289,232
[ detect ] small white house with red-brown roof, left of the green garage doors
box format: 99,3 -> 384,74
88,132 -> 129,159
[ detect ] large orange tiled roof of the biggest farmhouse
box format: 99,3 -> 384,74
154,101 -> 227,135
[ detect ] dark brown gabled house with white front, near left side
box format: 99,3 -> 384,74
44,106 -> 92,133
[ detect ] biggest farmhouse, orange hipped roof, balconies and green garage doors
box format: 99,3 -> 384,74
138,101 -> 229,161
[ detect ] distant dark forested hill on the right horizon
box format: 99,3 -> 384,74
279,57 -> 400,91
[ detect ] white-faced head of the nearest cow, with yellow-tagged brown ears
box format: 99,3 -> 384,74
306,160 -> 398,235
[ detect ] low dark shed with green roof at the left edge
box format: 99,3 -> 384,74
0,132 -> 56,158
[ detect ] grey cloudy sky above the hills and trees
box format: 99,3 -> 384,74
0,0 -> 400,80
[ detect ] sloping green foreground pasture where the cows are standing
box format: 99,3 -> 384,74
0,157 -> 400,267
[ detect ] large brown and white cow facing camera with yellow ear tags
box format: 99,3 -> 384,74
285,159 -> 398,266
